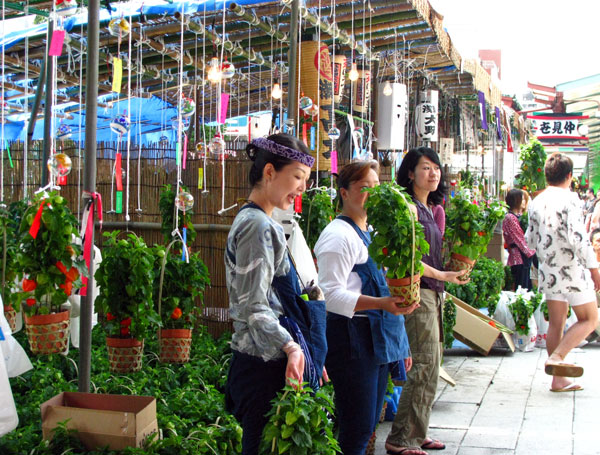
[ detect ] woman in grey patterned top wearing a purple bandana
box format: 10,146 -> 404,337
225,134 -> 326,455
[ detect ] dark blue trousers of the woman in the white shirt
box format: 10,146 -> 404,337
325,317 -> 390,455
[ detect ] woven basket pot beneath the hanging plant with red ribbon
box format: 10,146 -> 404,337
24,311 -> 71,354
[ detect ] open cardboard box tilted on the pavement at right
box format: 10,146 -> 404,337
446,293 -> 515,355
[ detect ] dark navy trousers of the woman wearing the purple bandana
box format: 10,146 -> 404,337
225,350 -> 287,455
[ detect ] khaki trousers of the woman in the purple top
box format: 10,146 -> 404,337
387,289 -> 442,447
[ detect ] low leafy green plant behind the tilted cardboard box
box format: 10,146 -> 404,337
446,256 -> 504,315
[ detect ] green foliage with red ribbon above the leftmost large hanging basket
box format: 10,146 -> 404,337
10,191 -> 87,315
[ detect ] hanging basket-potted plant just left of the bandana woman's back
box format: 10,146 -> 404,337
154,241 -> 210,363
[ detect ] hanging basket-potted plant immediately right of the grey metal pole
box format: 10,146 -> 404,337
94,231 -> 160,373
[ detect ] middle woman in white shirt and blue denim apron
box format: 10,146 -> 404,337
315,161 -> 418,455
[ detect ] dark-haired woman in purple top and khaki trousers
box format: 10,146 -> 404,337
385,147 -> 467,455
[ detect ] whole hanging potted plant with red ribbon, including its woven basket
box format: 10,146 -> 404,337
11,192 -> 86,354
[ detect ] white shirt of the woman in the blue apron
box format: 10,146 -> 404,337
314,219 -> 369,318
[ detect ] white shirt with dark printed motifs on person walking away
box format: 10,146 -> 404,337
525,186 -> 598,294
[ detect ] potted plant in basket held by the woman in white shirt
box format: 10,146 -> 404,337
365,183 -> 429,306
